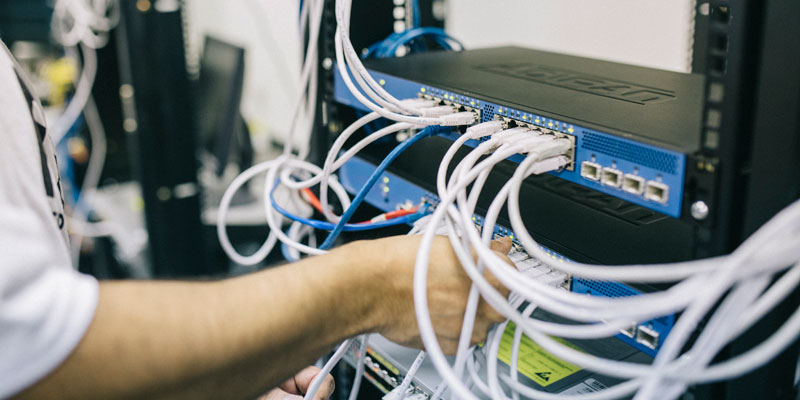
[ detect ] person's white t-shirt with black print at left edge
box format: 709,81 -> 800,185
0,42 -> 98,398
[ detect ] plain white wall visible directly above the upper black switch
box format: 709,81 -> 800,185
445,0 -> 698,72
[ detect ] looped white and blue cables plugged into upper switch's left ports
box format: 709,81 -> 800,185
217,0 -> 475,265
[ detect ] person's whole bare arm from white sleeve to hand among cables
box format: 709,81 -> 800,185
19,237 -> 508,399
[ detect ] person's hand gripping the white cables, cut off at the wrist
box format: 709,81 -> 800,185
348,236 -> 511,354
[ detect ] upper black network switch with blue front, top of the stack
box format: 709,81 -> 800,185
334,48 -> 703,218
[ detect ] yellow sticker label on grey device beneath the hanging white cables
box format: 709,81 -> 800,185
497,322 -> 581,387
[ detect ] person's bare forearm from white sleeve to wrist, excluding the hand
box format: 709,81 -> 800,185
16,241 -> 382,399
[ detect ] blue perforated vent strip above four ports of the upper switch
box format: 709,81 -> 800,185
581,131 -> 678,175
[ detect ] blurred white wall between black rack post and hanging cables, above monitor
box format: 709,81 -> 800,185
187,0 -> 301,153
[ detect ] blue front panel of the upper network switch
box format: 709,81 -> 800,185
334,70 -> 686,218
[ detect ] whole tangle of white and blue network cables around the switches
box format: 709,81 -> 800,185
218,0 -> 800,400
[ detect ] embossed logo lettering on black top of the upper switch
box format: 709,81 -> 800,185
478,64 -> 675,105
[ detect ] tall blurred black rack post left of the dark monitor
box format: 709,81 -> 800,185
117,0 -> 212,277
